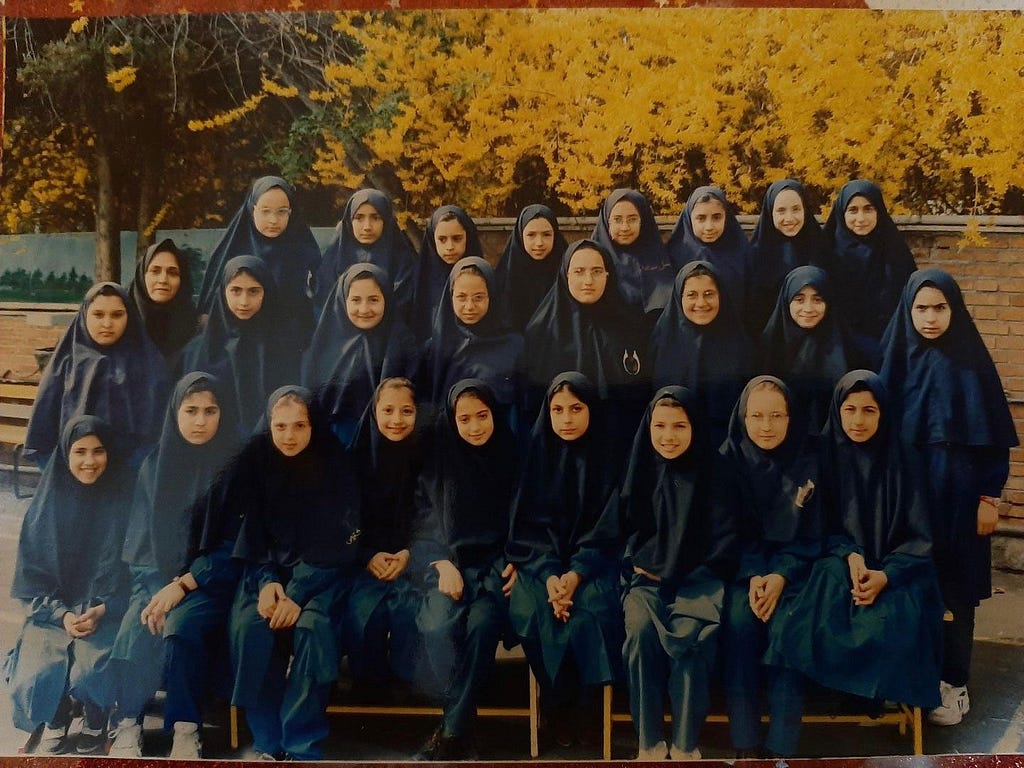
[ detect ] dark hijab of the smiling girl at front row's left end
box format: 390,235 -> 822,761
10,415 -> 132,612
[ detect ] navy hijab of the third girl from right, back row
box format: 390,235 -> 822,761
668,186 -> 753,316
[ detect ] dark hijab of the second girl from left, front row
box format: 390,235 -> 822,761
124,371 -> 239,581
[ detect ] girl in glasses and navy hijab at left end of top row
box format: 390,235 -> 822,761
193,176 -> 321,339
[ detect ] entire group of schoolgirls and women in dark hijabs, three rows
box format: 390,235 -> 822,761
4,176 -> 1018,761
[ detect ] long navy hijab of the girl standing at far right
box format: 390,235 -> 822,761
881,269 -> 1018,447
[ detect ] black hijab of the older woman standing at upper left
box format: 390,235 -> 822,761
128,238 -> 199,369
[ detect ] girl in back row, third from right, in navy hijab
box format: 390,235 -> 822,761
667,186 -> 754,317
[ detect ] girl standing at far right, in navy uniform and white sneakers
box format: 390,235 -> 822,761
880,269 -> 1019,725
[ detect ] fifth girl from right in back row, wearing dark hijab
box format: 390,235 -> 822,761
496,205 -> 568,333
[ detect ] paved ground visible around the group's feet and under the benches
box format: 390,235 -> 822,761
0,478 -> 1024,761
